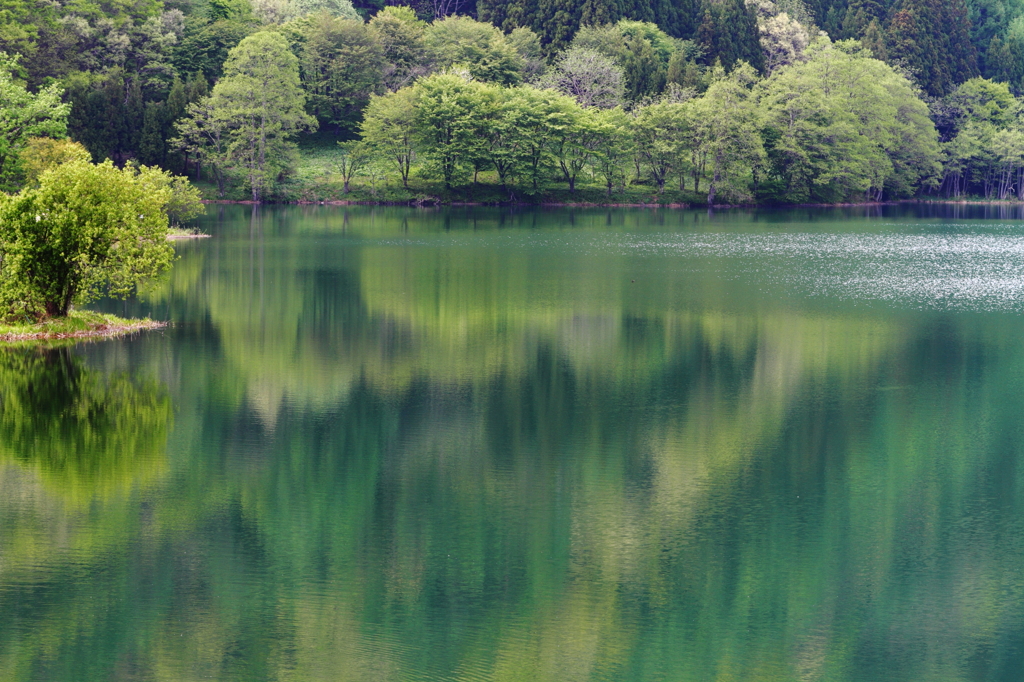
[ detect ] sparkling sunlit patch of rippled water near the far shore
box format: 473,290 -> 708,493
368,223 -> 1024,310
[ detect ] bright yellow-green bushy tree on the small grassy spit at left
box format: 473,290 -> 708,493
0,161 -> 173,317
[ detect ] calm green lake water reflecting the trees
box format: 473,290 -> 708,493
6,206 -> 1024,682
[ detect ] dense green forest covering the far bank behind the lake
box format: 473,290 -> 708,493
0,0 -> 1024,203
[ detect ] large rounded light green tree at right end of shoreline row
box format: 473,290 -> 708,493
760,38 -> 940,202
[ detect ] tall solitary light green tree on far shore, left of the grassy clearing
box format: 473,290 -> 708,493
210,31 -> 316,202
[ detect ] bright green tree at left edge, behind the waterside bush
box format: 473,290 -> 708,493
0,52 -> 71,188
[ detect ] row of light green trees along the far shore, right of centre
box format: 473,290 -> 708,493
350,39 -> 941,204
